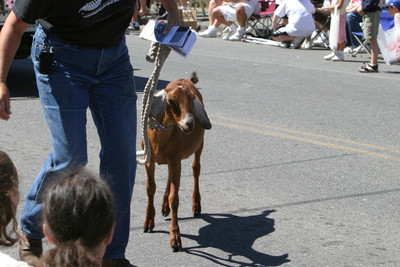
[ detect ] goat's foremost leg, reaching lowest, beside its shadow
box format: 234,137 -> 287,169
168,159 -> 182,252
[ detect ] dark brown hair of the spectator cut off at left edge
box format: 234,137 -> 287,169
0,150 -> 18,246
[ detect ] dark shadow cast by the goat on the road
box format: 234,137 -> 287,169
180,210 -> 290,266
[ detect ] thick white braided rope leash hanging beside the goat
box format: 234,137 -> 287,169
136,42 -> 171,165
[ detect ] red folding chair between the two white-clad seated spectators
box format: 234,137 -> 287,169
246,0 -> 275,38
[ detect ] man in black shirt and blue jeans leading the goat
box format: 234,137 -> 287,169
0,0 -> 179,267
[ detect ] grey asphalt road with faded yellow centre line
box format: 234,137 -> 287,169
0,35 -> 400,266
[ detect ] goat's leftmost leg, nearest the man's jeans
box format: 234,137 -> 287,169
144,161 -> 156,233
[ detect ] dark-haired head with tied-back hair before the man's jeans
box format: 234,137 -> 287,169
43,171 -> 114,266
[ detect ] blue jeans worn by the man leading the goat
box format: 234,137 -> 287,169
21,26 -> 137,258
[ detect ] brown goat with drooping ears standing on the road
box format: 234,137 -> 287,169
142,72 -> 211,252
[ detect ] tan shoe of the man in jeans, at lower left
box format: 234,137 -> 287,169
18,230 -> 43,266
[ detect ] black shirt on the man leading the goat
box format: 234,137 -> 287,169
13,0 -> 136,48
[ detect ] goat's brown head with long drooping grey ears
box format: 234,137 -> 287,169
151,80 -> 211,134
